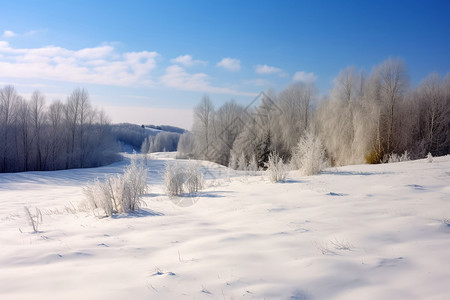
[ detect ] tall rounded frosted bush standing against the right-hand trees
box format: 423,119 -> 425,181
291,132 -> 327,176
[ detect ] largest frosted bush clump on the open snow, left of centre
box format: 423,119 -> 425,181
83,156 -> 147,217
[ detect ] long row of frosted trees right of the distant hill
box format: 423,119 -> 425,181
178,59 -> 450,167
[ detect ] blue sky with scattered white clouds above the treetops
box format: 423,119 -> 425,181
0,0 -> 450,128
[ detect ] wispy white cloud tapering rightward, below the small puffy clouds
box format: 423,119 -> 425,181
161,65 -> 256,96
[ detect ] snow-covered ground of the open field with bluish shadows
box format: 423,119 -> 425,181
0,154 -> 450,300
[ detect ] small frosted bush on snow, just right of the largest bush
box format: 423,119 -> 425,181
164,162 -> 204,197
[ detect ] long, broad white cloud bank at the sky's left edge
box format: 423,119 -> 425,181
0,41 -> 159,86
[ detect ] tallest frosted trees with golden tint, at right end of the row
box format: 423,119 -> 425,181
314,59 -> 450,165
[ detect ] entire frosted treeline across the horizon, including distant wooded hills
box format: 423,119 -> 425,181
0,58 -> 450,172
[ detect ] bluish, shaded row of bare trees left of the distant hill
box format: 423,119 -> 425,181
0,86 -> 118,172
